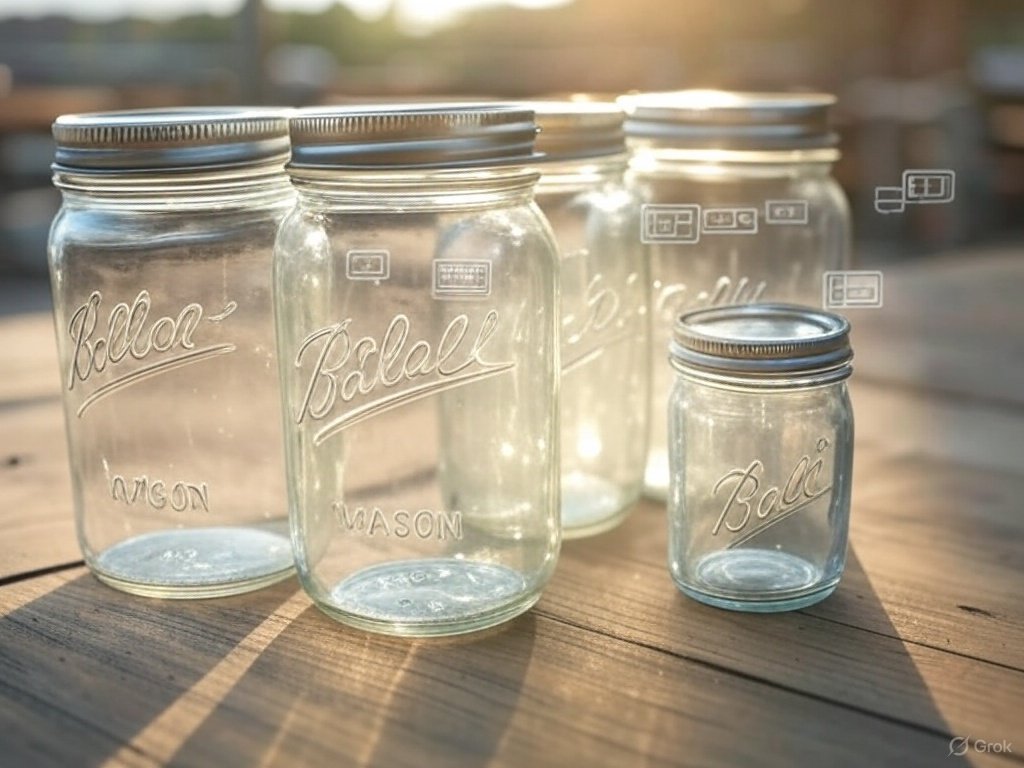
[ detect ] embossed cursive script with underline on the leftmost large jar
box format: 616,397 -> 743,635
68,291 -> 238,418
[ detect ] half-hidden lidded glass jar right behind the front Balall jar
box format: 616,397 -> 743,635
531,101 -> 649,539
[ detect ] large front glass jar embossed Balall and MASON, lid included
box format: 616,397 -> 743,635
274,104 -> 560,636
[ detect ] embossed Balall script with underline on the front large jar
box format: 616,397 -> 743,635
295,309 -> 515,445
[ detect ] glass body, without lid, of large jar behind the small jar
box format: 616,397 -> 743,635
630,147 -> 850,499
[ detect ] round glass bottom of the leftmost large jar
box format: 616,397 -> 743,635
89,526 -> 294,599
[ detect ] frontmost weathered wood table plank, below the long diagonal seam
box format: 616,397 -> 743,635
0,570 -> 974,768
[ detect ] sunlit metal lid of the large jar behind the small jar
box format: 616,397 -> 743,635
620,90 -> 839,150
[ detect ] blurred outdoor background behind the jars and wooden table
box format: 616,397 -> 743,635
0,0 -> 1024,284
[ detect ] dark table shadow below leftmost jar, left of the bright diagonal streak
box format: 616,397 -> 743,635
0,573 -> 296,766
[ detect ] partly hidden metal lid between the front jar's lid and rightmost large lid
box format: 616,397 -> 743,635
529,101 -> 626,163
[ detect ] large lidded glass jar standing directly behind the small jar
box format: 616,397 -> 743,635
622,90 -> 850,499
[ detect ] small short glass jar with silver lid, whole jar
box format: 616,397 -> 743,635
668,304 -> 853,612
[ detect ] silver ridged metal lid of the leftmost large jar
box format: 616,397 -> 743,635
53,106 -> 289,173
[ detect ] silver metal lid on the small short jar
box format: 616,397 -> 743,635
669,304 -> 853,383
